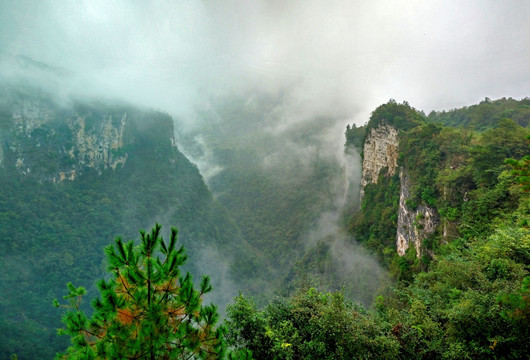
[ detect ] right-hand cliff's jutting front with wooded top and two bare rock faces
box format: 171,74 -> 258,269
347,101 -> 440,257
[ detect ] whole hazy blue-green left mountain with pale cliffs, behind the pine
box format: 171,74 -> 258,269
0,88 -> 248,359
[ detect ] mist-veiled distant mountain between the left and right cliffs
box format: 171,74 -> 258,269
180,93 -> 388,305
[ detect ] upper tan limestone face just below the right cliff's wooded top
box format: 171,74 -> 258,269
361,125 -> 399,198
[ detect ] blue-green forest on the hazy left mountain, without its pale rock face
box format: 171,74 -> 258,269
0,93 -> 245,359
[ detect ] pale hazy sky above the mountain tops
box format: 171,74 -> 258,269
0,0 -> 530,124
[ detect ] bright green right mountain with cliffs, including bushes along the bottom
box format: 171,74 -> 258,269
228,100 -> 530,359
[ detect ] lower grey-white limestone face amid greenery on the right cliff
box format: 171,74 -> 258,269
396,170 -> 440,257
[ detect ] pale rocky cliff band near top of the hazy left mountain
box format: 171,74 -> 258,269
6,99 -> 129,182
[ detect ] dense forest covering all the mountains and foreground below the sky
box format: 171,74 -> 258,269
0,89 -> 530,359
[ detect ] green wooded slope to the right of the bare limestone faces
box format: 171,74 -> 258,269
399,112 -> 528,240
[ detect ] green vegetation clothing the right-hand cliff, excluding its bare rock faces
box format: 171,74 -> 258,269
346,100 -> 530,270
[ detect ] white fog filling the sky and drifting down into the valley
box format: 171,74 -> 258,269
0,0 -> 530,306
